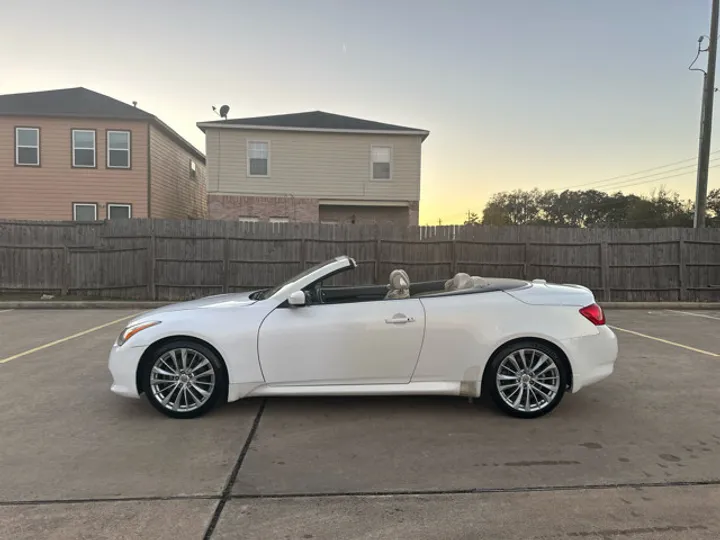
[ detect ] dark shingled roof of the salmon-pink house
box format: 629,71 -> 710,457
0,86 -> 205,163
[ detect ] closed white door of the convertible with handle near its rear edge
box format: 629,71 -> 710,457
258,298 -> 425,385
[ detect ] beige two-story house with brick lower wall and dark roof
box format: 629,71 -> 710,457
197,111 -> 429,226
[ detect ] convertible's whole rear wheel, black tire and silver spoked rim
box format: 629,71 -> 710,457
485,340 -> 568,418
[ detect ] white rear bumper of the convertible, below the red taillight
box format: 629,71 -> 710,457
562,326 -> 618,393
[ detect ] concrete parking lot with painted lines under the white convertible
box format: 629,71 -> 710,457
0,310 -> 720,540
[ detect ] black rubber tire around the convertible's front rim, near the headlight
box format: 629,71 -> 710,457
141,339 -> 228,419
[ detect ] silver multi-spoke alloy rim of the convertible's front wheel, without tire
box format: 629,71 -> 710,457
150,348 -> 215,412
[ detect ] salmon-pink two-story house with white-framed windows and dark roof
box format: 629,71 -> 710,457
0,88 -> 207,221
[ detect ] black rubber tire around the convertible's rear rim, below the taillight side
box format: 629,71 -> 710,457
483,339 -> 568,418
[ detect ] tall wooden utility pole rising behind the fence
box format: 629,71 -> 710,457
694,0 -> 720,229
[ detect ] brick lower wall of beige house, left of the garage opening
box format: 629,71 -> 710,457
208,194 -> 319,222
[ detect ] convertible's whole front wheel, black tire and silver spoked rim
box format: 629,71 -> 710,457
142,340 -> 227,418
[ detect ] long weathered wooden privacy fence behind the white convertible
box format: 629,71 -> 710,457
0,220 -> 720,301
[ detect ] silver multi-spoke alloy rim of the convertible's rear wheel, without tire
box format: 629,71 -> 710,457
495,348 -> 560,413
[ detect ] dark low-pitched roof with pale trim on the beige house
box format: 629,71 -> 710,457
197,111 -> 430,140
